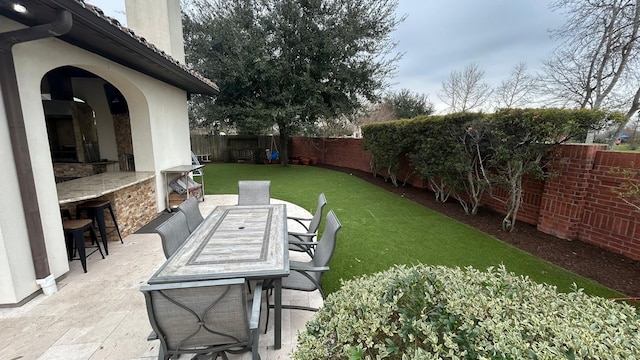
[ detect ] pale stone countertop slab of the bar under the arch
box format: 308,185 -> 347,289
56,171 -> 155,205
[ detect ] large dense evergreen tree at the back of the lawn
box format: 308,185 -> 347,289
184,0 -> 402,163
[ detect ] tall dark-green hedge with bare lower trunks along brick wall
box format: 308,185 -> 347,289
362,109 -> 619,231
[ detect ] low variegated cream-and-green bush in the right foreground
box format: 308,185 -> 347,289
292,265 -> 640,360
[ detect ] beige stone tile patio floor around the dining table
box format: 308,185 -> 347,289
0,195 -> 322,360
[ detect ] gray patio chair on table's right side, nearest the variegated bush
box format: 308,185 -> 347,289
264,210 -> 342,333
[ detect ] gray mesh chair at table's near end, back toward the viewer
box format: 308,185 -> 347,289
140,278 -> 262,360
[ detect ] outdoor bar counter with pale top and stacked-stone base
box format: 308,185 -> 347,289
56,171 -> 157,240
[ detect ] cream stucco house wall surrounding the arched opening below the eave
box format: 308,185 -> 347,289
0,16 -> 191,304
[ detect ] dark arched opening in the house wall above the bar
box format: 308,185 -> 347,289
40,66 -> 135,182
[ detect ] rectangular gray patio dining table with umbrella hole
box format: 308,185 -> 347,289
148,204 -> 289,349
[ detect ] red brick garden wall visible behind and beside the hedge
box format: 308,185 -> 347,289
292,137 -> 640,260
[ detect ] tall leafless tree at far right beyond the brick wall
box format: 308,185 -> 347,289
542,0 -> 640,143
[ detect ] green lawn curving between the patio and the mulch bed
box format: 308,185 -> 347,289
205,164 -> 622,297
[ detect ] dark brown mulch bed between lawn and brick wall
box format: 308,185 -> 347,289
319,165 -> 640,297
